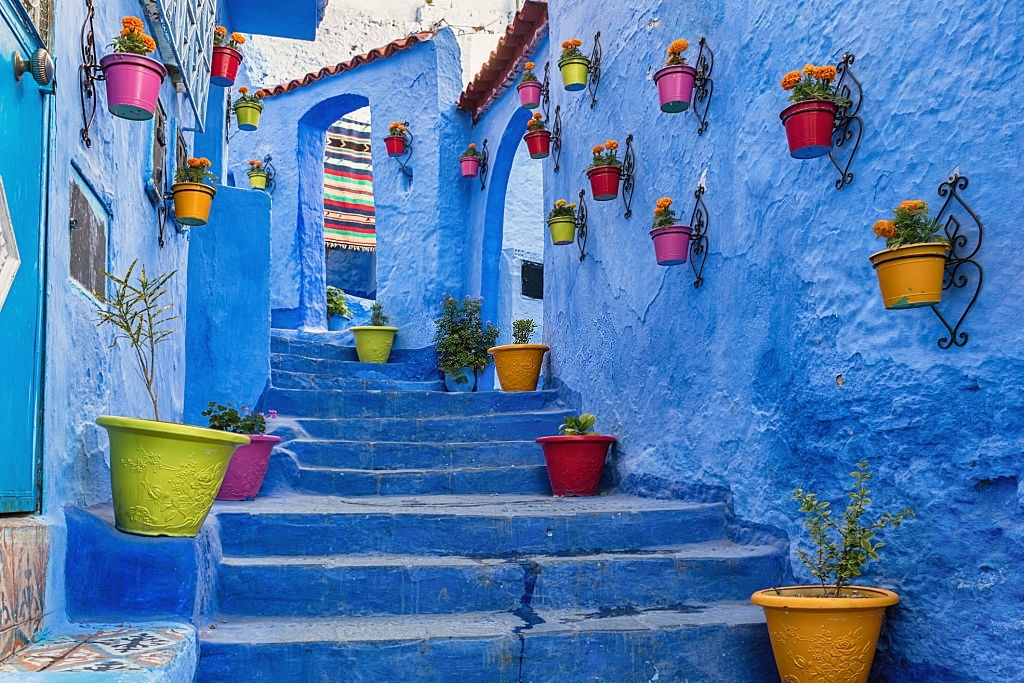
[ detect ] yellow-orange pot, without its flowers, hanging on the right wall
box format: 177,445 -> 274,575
868,242 -> 949,308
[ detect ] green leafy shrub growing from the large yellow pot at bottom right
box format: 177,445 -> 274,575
793,460 -> 913,598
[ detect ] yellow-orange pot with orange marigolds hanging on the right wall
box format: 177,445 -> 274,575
869,200 -> 949,308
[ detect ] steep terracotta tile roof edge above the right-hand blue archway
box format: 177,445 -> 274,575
456,0 -> 548,124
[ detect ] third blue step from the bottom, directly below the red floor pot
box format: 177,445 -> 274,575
211,495 -> 725,557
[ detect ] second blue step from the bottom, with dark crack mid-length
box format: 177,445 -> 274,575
217,540 -> 785,616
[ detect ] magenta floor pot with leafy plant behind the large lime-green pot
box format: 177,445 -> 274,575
203,400 -> 281,501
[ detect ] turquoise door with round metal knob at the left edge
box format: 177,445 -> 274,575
0,0 -> 49,512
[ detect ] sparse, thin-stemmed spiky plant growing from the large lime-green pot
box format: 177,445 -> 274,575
93,259 -> 178,420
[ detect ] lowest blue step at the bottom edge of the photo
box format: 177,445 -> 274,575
198,606 -> 778,683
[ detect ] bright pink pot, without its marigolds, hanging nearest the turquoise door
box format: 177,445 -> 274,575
99,52 -> 167,121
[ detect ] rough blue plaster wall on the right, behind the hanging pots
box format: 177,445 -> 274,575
467,0 -> 1024,681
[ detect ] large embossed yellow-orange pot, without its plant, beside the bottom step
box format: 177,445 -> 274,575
751,586 -> 899,683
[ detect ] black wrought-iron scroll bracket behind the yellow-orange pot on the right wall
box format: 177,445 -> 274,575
931,171 -> 985,348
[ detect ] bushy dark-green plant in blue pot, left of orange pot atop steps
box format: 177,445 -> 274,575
434,294 -> 498,391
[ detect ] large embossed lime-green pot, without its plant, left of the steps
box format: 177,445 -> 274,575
96,415 -> 249,538
